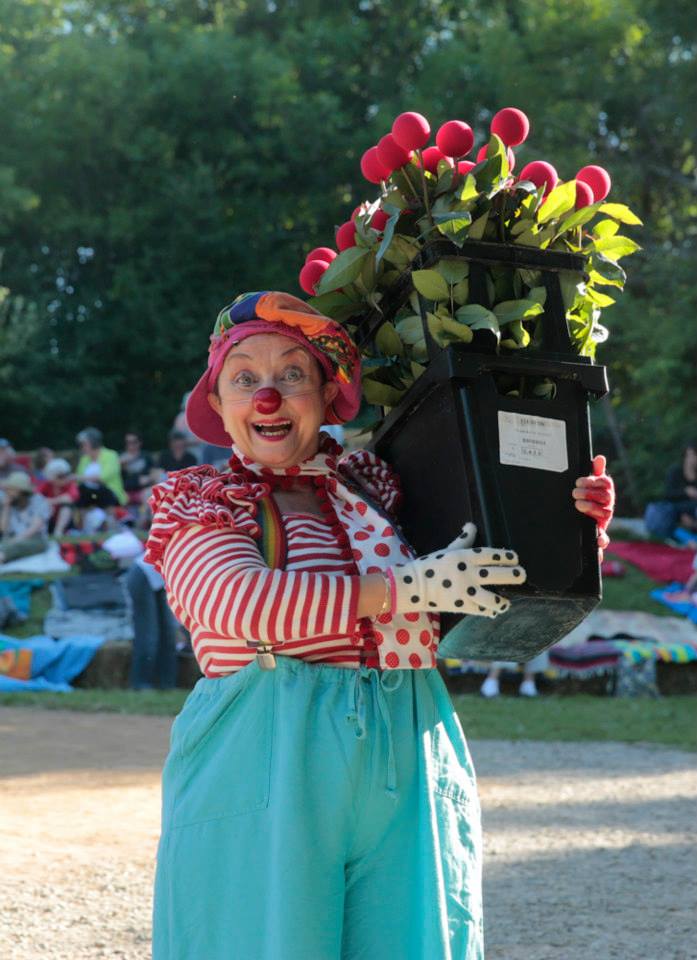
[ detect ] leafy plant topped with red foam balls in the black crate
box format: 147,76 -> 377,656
296,108 -> 641,407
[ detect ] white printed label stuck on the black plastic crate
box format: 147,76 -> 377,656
499,410 -> 569,473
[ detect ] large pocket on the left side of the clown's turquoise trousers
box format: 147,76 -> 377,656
169,666 -> 275,828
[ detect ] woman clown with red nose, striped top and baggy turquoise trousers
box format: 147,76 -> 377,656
145,291 -> 612,960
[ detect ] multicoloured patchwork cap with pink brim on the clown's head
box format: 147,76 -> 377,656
186,291 -> 361,447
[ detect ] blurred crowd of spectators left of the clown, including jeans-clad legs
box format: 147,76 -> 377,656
0,417 -> 213,690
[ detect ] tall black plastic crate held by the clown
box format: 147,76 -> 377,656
356,237 -> 607,662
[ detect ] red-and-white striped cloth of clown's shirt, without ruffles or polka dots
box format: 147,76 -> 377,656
162,514 -> 378,677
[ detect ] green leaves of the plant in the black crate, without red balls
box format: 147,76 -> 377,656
294,123 -> 641,382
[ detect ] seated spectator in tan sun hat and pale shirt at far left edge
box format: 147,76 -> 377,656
0,470 -> 51,563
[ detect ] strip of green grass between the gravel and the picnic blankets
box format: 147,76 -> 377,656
0,690 -> 697,750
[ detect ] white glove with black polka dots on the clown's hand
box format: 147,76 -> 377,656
392,545 -> 525,618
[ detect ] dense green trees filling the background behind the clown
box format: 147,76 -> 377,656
0,0 -> 697,510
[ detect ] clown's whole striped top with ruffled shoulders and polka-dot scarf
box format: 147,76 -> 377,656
146,450 -> 440,677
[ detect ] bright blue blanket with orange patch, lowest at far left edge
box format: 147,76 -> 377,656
0,634 -> 104,693
